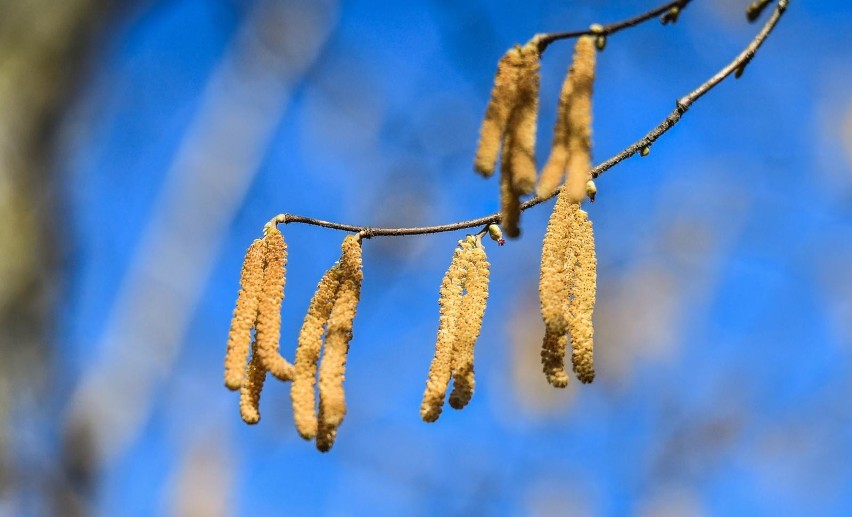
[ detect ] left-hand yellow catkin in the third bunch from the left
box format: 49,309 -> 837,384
420,241 -> 470,422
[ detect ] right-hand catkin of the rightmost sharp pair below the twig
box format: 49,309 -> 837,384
569,210 -> 597,383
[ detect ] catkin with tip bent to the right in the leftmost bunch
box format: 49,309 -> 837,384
256,227 -> 294,381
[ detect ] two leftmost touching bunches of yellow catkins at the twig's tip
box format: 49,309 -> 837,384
225,224 -> 363,452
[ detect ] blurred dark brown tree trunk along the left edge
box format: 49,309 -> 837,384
0,0 -> 117,515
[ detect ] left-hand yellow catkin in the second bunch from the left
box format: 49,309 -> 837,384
290,264 -> 340,440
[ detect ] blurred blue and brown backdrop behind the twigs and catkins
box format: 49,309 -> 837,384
0,0 -> 852,516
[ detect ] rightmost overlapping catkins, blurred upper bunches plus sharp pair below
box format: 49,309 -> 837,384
474,36 -> 603,387
